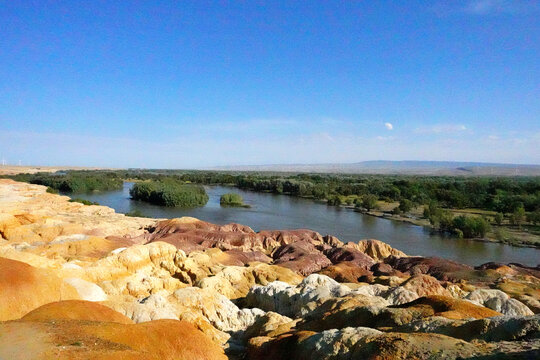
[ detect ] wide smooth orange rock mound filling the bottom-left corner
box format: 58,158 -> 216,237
0,320 -> 227,360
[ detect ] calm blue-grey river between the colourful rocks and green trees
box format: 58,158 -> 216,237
73,182 -> 540,266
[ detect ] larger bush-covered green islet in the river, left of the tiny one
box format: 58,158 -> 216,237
129,179 -> 208,207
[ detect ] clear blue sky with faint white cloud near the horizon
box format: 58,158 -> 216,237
0,0 -> 540,168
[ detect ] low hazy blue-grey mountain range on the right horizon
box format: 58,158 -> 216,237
211,160 -> 540,176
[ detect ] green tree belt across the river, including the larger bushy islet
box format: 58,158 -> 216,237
5,169 -> 540,237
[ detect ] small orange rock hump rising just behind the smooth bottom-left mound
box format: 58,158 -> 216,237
21,300 -> 133,324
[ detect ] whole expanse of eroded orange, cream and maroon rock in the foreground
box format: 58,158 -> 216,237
0,180 -> 540,360
